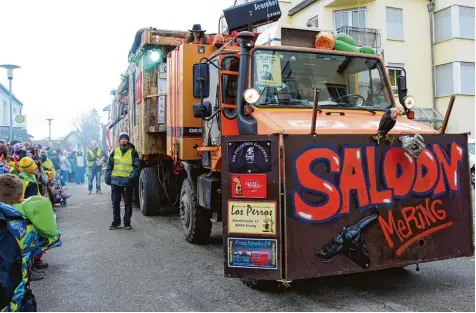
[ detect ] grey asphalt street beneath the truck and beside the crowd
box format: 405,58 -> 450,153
32,185 -> 475,312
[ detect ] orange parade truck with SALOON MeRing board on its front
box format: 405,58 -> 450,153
110,1 -> 474,287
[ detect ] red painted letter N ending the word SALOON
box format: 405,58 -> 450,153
433,142 -> 463,195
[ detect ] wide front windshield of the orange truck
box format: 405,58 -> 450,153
253,50 -> 393,110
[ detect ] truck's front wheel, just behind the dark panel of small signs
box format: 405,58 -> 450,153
180,178 -> 212,244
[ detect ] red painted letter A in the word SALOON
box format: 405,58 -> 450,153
339,148 -> 369,214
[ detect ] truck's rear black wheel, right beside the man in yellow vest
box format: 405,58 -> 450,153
139,167 -> 162,216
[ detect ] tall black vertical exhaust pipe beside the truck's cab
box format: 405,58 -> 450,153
236,31 -> 258,135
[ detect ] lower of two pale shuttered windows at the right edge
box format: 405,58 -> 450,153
436,62 -> 475,97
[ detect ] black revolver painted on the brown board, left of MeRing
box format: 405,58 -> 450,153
314,208 -> 379,269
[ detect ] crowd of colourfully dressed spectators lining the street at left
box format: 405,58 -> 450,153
0,141 -> 105,312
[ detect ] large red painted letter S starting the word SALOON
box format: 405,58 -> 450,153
293,148 -> 341,221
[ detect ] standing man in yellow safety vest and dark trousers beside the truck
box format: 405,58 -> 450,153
105,133 -> 140,230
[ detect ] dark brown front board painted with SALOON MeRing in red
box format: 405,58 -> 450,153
284,135 -> 472,279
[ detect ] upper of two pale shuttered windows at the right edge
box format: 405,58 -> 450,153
434,5 -> 475,43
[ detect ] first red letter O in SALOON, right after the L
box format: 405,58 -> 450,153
384,147 -> 415,197
